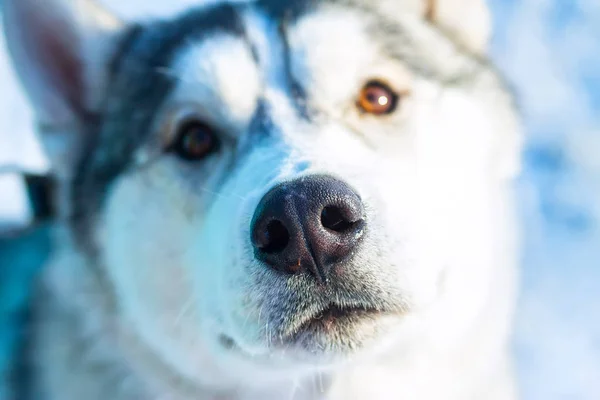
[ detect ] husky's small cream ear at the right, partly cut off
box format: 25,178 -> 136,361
422,0 -> 492,54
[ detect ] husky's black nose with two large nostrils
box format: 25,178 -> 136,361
251,176 -> 366,282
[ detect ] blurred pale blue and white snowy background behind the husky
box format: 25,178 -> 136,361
0,0 -> 600,400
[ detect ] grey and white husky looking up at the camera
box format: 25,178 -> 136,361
4,0 -> 522,400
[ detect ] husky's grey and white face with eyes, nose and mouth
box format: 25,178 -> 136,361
4,1 -> 518,390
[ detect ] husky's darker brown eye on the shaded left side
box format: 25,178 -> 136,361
173,121 -> 219,161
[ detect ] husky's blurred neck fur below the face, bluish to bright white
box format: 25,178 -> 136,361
18,223 -> 515,400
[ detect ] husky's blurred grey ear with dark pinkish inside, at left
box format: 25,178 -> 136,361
3,0 -> 124,175
